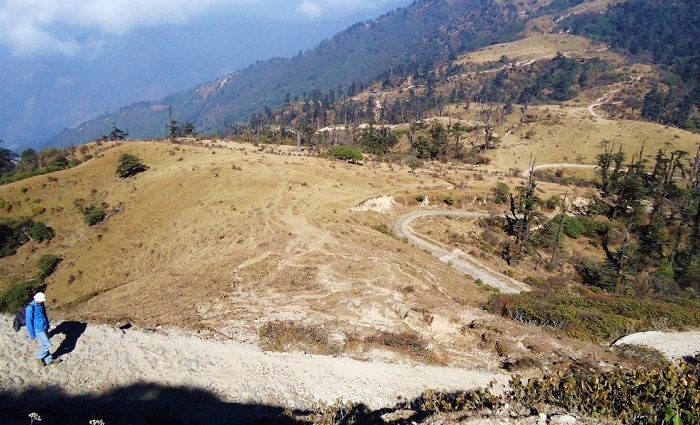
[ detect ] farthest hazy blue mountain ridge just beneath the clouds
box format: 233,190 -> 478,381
0,6 -> 410,153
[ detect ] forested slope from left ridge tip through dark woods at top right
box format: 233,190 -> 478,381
53,0 -> 700,146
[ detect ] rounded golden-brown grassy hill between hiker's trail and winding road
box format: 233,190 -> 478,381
0,133 -> 636,369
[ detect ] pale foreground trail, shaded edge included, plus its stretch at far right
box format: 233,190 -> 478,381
0,315 -> 700,425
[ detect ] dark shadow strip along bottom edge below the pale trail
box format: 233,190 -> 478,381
0,384 -> 442,425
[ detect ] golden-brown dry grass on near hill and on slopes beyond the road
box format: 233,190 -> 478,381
0,36 -> 699,380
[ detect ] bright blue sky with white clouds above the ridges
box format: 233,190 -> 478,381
0,0 -> 408,57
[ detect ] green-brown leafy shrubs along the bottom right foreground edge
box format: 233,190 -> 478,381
410,358 -> 700,425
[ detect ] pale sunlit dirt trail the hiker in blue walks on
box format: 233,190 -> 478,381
0,315 -> 508,424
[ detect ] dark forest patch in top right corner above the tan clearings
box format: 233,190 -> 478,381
561,0 -> 700,130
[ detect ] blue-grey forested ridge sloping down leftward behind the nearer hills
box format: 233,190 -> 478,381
51,0 -> 556,146
